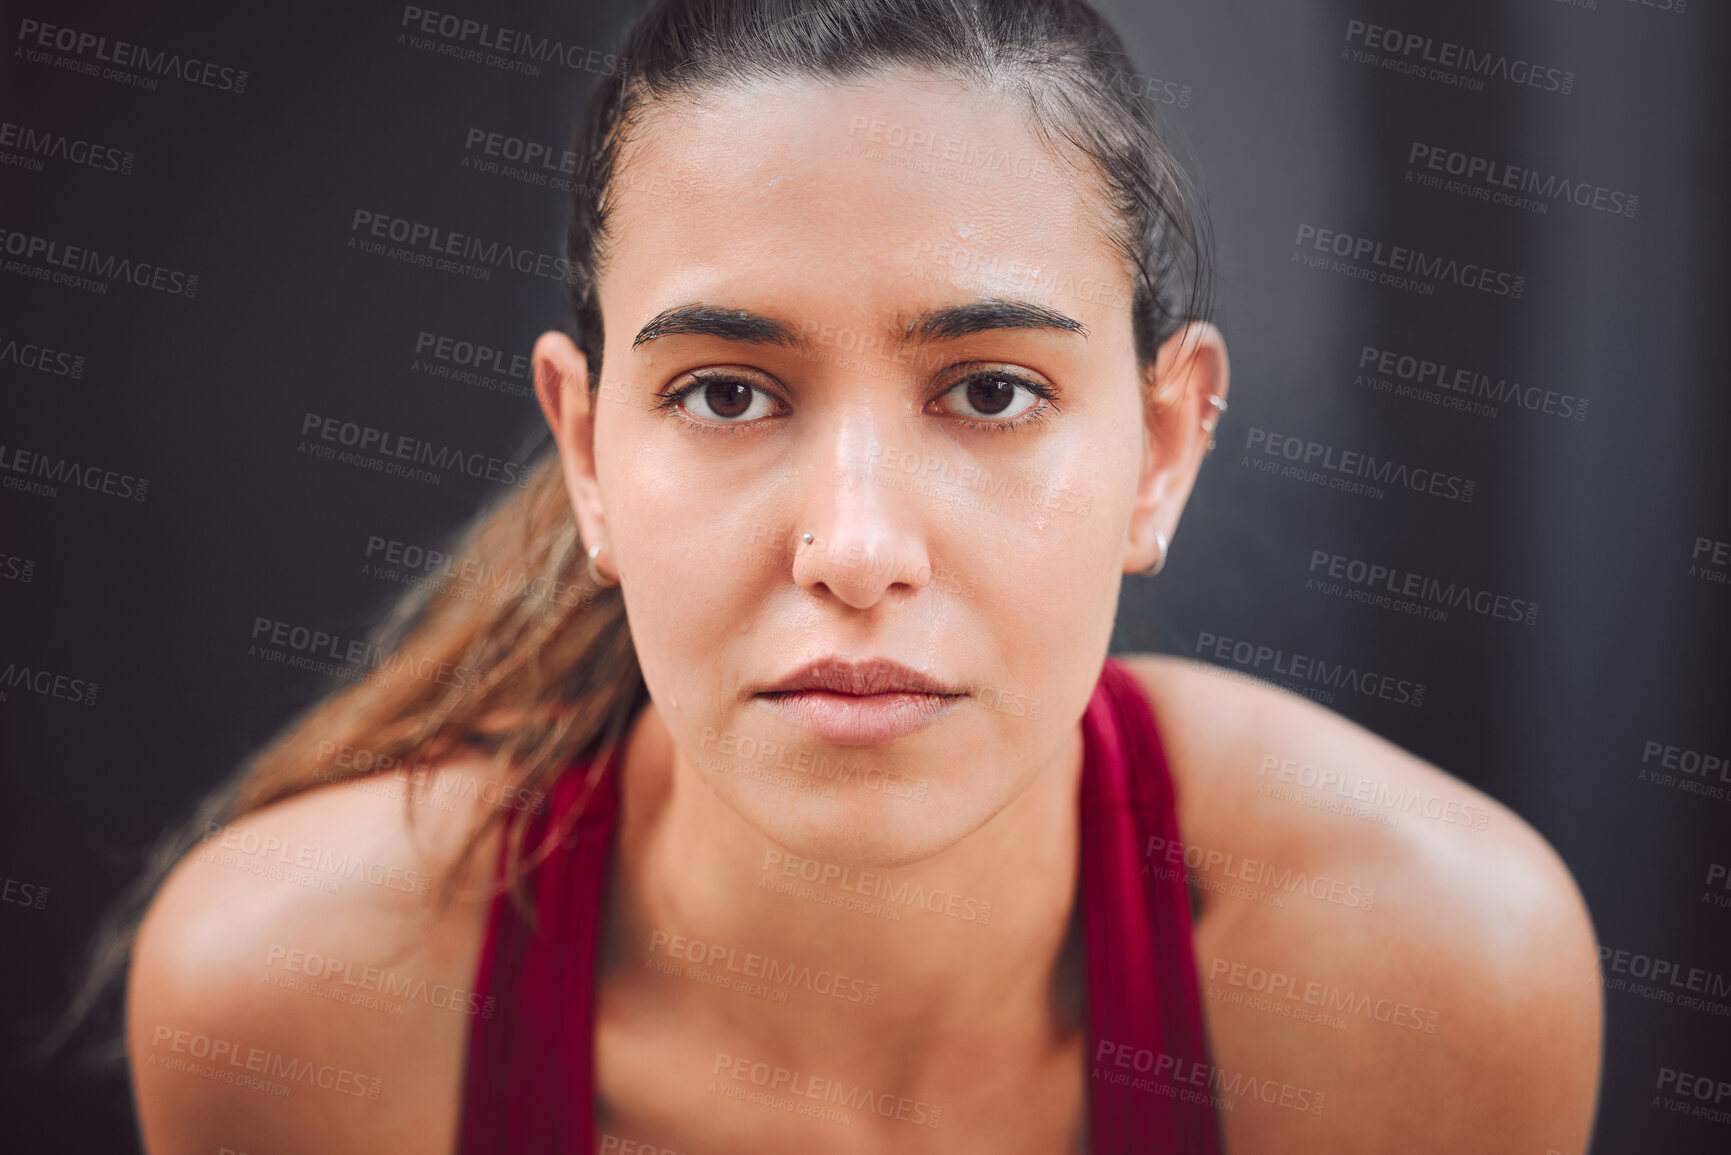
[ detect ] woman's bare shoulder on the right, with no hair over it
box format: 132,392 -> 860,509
1125,655 -> 1603,1155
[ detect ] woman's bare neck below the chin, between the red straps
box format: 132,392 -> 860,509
609,701 -> 1082,1058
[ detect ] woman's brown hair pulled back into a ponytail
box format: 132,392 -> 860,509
57,0 -> 1212,1058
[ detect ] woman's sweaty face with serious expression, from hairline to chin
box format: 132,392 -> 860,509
556,76 -> 1205,866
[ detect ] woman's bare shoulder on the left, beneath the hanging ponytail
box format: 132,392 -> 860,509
126,758 -> 509,1155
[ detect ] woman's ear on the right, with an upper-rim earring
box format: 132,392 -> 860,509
1123,320 -> 1231,573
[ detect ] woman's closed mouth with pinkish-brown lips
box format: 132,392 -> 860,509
753,658 -> 968,746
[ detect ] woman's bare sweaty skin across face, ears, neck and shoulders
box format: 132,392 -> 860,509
128,74 -> 1601,1155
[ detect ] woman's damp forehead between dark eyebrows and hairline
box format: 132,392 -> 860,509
601,73 -> 1130,324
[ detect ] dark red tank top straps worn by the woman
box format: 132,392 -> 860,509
459,658 -> 1220,1155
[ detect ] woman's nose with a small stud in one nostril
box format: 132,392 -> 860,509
793,412 -> 931,610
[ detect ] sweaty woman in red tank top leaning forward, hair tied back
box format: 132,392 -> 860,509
126,0 -> 1601,1155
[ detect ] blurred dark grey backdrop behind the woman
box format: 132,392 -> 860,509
0,0 -> 1731,1155
